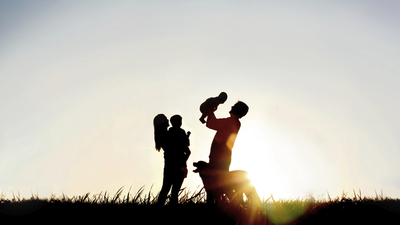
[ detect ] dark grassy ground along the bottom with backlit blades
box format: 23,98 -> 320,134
0,188 -> 400,225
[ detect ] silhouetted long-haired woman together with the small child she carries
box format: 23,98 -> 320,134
154,114 -> 190,204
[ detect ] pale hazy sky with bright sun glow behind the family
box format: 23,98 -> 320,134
0,0 -> 400,198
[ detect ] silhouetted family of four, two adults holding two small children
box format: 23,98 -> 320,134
153,92 -> 249,205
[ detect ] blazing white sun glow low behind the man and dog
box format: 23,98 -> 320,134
231,114 -> 320,199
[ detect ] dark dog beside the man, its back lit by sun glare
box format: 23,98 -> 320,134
193,161 -> 261,204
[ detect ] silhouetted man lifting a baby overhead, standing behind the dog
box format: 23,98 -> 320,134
206,101 -> 249,172
